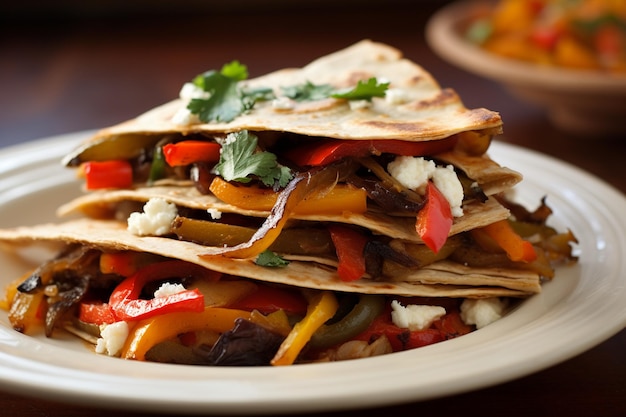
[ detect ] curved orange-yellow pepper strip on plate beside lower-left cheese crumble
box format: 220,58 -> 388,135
121,307 -> 251,361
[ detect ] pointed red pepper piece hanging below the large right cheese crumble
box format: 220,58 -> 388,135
415,181 -> 453,253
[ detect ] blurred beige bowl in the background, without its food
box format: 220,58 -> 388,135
426,0 -> 626,136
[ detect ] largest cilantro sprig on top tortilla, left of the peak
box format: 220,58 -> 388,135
187,61 -> 273,123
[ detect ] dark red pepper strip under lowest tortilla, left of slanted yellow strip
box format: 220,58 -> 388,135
228,285 -> 308,315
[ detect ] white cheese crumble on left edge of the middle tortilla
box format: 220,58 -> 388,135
128,198 -> 178,236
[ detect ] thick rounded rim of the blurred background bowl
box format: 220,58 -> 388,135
425,0 -> 626,95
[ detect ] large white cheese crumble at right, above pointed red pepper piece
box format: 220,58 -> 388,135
387,156 -> 463,217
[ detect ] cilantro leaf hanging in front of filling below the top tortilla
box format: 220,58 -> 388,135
214,130 -> 293,187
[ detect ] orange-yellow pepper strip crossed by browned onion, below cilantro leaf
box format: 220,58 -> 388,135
209,177 -> 367,214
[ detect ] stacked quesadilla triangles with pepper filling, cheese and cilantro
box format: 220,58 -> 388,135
0,41 -> 575,364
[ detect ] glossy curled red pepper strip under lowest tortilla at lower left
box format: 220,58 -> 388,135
109,260 -> 211,321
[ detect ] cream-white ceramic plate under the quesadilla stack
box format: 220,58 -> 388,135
0,132 -> 626,414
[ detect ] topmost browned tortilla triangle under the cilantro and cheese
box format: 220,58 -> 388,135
64,40 -> 502,164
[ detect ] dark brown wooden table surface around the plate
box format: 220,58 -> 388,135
0,0 -> 626,417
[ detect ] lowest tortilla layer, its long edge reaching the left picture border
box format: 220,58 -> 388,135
0,219 -> 541,298
